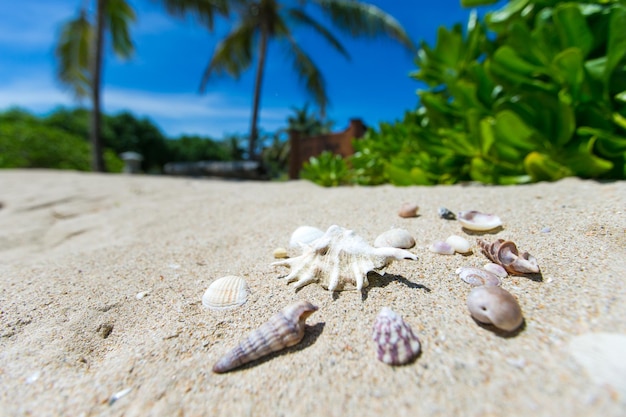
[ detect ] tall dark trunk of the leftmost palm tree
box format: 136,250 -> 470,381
89,0 -> 107,172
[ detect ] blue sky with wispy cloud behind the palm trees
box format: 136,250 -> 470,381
0,0 -> 502,139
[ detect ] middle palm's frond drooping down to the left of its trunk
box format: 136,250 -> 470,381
200,21 -> 257,92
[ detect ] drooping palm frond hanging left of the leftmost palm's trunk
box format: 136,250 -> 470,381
55,10 -> 94,98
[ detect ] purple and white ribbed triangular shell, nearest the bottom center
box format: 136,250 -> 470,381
372,307 -> 421,365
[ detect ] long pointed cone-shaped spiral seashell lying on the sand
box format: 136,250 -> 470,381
213,301 -> 317,374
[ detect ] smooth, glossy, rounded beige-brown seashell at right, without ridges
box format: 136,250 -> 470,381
467,286 -> 524,332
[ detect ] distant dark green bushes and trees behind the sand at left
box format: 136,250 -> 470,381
0,108 -> 243,173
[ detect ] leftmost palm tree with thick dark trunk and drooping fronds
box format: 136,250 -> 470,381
55,0 -> 228,172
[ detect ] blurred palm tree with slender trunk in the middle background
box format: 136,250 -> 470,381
200,0 -> 414,159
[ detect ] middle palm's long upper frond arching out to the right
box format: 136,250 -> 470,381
313,0 -> 415,50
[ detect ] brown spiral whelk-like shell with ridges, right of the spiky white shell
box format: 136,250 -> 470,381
478,239 -> 539,275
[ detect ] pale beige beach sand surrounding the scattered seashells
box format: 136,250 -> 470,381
0,170 -> 626,417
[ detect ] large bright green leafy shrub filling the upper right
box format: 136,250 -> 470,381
302,0 -> 626,185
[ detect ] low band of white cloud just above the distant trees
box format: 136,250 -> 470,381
0,74 -> 291,138
